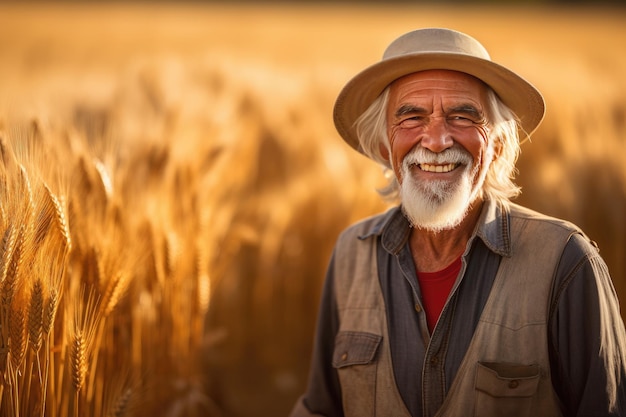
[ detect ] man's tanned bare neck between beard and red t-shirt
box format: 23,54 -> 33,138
409,201 -> 483,272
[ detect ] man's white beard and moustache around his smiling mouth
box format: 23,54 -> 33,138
400,146 -> 491,233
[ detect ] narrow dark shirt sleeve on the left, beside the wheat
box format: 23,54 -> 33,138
292,250 -> 343,417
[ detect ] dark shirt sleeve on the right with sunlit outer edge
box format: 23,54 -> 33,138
549,234 -> 626,416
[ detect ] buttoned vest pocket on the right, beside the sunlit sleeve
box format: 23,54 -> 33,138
475,362 -> 541,417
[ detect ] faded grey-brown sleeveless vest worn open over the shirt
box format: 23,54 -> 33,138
333,205 -> 580,417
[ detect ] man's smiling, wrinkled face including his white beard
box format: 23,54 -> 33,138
387,70 -> 493,232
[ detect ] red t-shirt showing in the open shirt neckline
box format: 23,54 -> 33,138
417,256 -> 461,333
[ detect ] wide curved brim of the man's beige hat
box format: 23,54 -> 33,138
333,52 -> 545,152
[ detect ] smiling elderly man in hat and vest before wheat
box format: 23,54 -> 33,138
291,29 -> 626,417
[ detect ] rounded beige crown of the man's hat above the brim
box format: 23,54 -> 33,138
383,28 -> 491,60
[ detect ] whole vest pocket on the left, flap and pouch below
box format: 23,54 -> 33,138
333,331 -> 382,417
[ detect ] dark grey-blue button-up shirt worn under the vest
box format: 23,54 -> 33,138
296,202 -> 625,416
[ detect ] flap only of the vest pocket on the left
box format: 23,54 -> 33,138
333,331 -> 383,368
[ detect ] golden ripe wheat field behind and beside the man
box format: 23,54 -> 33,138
0,2 -> 626,417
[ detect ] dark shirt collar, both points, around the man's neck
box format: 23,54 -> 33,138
359,200 -> 511,257
